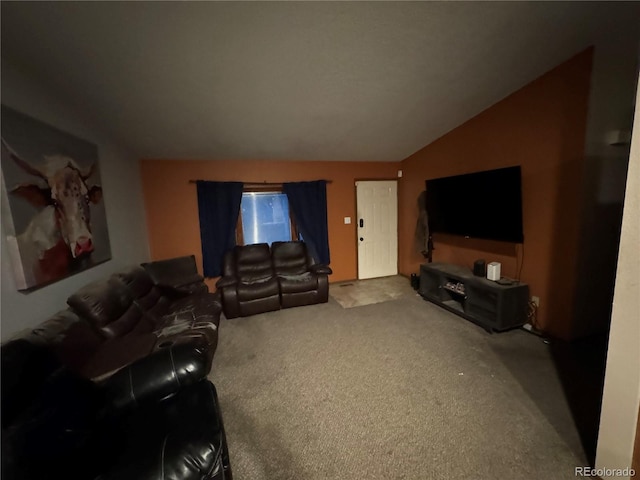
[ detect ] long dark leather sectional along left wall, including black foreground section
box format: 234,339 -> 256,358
1,256 -> 231,480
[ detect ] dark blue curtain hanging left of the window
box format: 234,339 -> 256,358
196,180 -> 243,277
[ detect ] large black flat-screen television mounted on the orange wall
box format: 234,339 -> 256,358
426,166 -> 524,243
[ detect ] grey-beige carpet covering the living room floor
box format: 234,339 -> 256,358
211,280 -> 587,480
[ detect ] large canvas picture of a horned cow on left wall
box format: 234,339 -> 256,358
1,105 -> 111,291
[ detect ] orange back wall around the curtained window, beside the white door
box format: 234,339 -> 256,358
141,160 -> 399,287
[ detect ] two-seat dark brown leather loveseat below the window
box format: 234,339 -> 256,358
216,242 -> 332,318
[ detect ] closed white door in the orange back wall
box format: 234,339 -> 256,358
356,180 -> 398,279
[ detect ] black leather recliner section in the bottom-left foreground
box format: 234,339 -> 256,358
1,334 -> 232,480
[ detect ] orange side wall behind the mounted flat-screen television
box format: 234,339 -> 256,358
399,49 -> 593,338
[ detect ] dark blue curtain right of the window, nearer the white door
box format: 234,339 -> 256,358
282,180 -> 331,265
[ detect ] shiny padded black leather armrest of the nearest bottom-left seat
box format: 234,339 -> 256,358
101,339 -> 211,413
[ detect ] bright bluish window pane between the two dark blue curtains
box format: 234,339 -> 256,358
237,191 -> 297,245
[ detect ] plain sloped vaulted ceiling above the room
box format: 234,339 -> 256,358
1,1 -> 640,161
